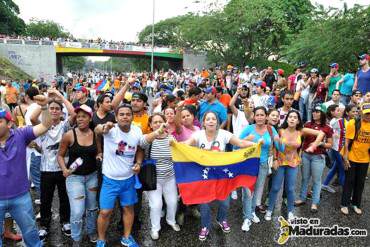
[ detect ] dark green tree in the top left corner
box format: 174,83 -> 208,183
0,0 -> 26,35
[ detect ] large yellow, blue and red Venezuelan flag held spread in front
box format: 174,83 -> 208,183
171,142 -> 261,204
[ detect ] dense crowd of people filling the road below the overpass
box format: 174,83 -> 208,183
0,54 -> 370,247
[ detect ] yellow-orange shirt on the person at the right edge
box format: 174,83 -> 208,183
346,119 -> 370,163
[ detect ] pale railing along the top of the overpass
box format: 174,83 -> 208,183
0,38 -> 182,53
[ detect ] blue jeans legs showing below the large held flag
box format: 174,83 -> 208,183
199,196 -> 230,229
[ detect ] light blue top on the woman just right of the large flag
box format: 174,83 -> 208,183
239,124 -> 279,164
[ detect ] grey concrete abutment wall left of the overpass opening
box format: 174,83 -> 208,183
0,43 -> 56,82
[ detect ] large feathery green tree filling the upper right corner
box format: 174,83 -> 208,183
283,5 -> 370,71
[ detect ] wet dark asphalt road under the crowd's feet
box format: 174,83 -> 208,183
4,168 -> 370,247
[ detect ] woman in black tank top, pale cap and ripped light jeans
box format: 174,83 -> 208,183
58,105 -> 98,246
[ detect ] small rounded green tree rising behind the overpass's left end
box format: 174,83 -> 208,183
26,18 -> 70,39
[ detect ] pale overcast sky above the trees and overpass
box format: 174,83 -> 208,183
13,0 -> 369,41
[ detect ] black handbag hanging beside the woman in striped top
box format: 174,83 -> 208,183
139,144 -> 157,191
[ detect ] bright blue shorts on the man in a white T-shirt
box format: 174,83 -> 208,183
99,175 -> 138,209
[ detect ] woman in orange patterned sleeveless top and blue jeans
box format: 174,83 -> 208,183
265,110 -> 325,221
